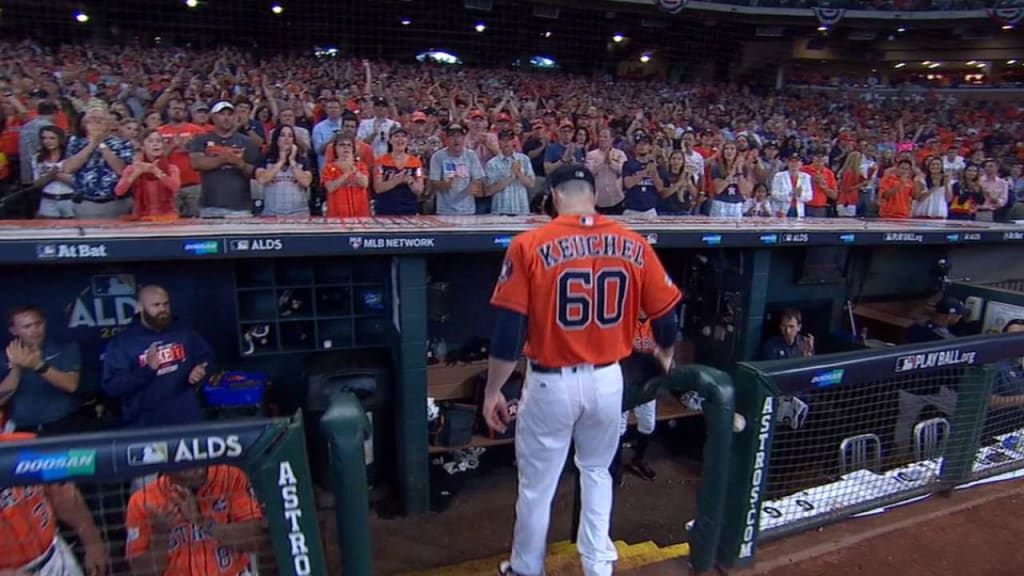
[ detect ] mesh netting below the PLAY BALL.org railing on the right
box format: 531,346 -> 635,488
760,360 -> 1024,538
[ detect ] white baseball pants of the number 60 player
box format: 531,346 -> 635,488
512,364 -> 623,576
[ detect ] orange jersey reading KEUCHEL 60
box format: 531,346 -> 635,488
490,215 -> 681,368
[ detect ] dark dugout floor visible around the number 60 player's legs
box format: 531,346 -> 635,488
323,434 -> 699,575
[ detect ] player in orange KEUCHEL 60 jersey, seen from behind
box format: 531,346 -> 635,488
483,165 -> 680,576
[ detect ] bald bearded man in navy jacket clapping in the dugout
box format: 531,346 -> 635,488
102,286 -> 214,427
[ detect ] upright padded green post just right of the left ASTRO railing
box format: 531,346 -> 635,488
319,393 -> 373,576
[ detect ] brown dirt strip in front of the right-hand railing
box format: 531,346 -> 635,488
740,481 -> 1024,576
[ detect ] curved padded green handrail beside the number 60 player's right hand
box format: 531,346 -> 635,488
637,365 -> 735,572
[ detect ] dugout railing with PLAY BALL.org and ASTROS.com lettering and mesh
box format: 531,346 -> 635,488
718,334 -> 1024,567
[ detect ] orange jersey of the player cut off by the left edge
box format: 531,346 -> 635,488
0,433 -> 57,570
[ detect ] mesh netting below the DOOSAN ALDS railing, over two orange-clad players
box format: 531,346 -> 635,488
0,461 -> 274,575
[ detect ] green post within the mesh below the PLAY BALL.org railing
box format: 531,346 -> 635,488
940,365 -> 997,493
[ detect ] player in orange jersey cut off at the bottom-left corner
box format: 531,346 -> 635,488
0,433 -> 108,576
